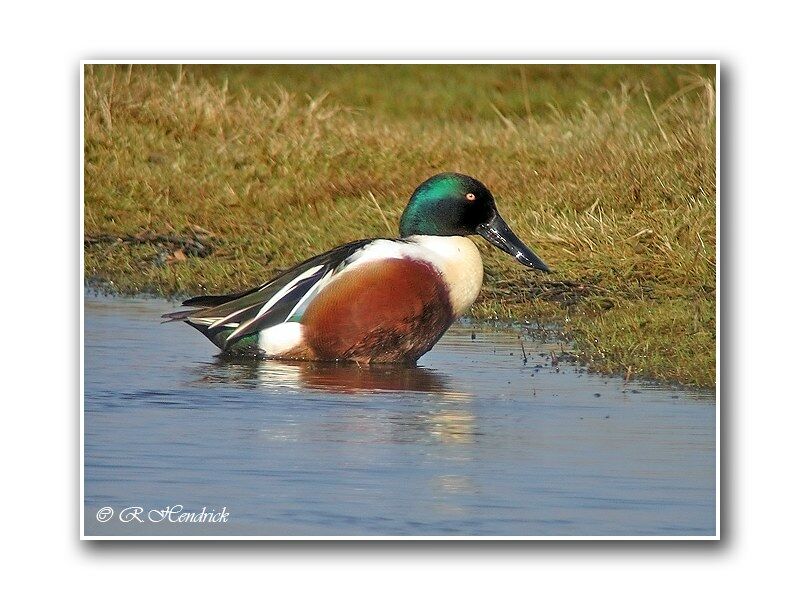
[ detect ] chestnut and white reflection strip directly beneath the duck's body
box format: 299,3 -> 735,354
197,355 -> 469,399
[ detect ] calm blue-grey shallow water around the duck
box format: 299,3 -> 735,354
84,294 -> 715,536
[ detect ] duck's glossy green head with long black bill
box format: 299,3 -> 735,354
400,173 -> 550,271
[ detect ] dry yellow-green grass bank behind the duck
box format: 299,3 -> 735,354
84,65 -> 716,386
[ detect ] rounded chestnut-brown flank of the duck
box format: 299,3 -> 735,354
302,259 -> 455,362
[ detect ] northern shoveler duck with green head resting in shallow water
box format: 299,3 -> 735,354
164,173 -> 550,363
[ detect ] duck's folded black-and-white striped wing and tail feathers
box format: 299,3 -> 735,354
163,239 -> 375,350
